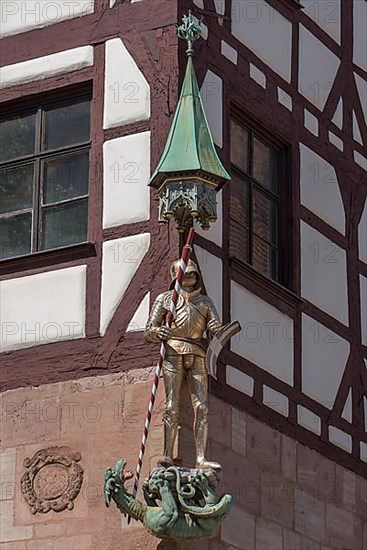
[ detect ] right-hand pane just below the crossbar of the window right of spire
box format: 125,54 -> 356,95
252,189 -> 278,248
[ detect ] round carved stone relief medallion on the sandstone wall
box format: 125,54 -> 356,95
20,447 -> 83,514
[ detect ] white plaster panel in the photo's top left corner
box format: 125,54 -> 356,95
0,0 -> 94,38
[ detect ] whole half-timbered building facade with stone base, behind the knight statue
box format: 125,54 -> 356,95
0,0 -> 367,550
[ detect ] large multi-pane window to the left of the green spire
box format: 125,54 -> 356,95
0,96 -> 90,259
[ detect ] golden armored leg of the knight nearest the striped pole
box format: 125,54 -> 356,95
163,355 -> 184,463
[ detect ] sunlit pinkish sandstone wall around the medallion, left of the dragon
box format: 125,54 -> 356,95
0,369 -> 163,550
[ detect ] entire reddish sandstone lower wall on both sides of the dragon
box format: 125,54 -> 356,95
0,369 -> 367,550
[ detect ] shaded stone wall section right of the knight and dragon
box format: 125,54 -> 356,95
179,388 -> 367,550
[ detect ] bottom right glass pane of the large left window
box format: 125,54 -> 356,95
41,199 -> 88,250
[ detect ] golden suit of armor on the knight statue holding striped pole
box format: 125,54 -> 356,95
144,260 -> 222,468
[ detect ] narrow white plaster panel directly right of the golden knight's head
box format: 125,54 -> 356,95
194,245 -> 223,319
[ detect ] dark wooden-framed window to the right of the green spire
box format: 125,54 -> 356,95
230,120 -> 282,281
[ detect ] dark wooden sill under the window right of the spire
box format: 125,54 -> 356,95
229,258 -> 303,317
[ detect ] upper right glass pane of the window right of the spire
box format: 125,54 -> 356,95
253,137 -> 278,192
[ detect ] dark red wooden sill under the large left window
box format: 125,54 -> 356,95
0,243 -> 96,275
